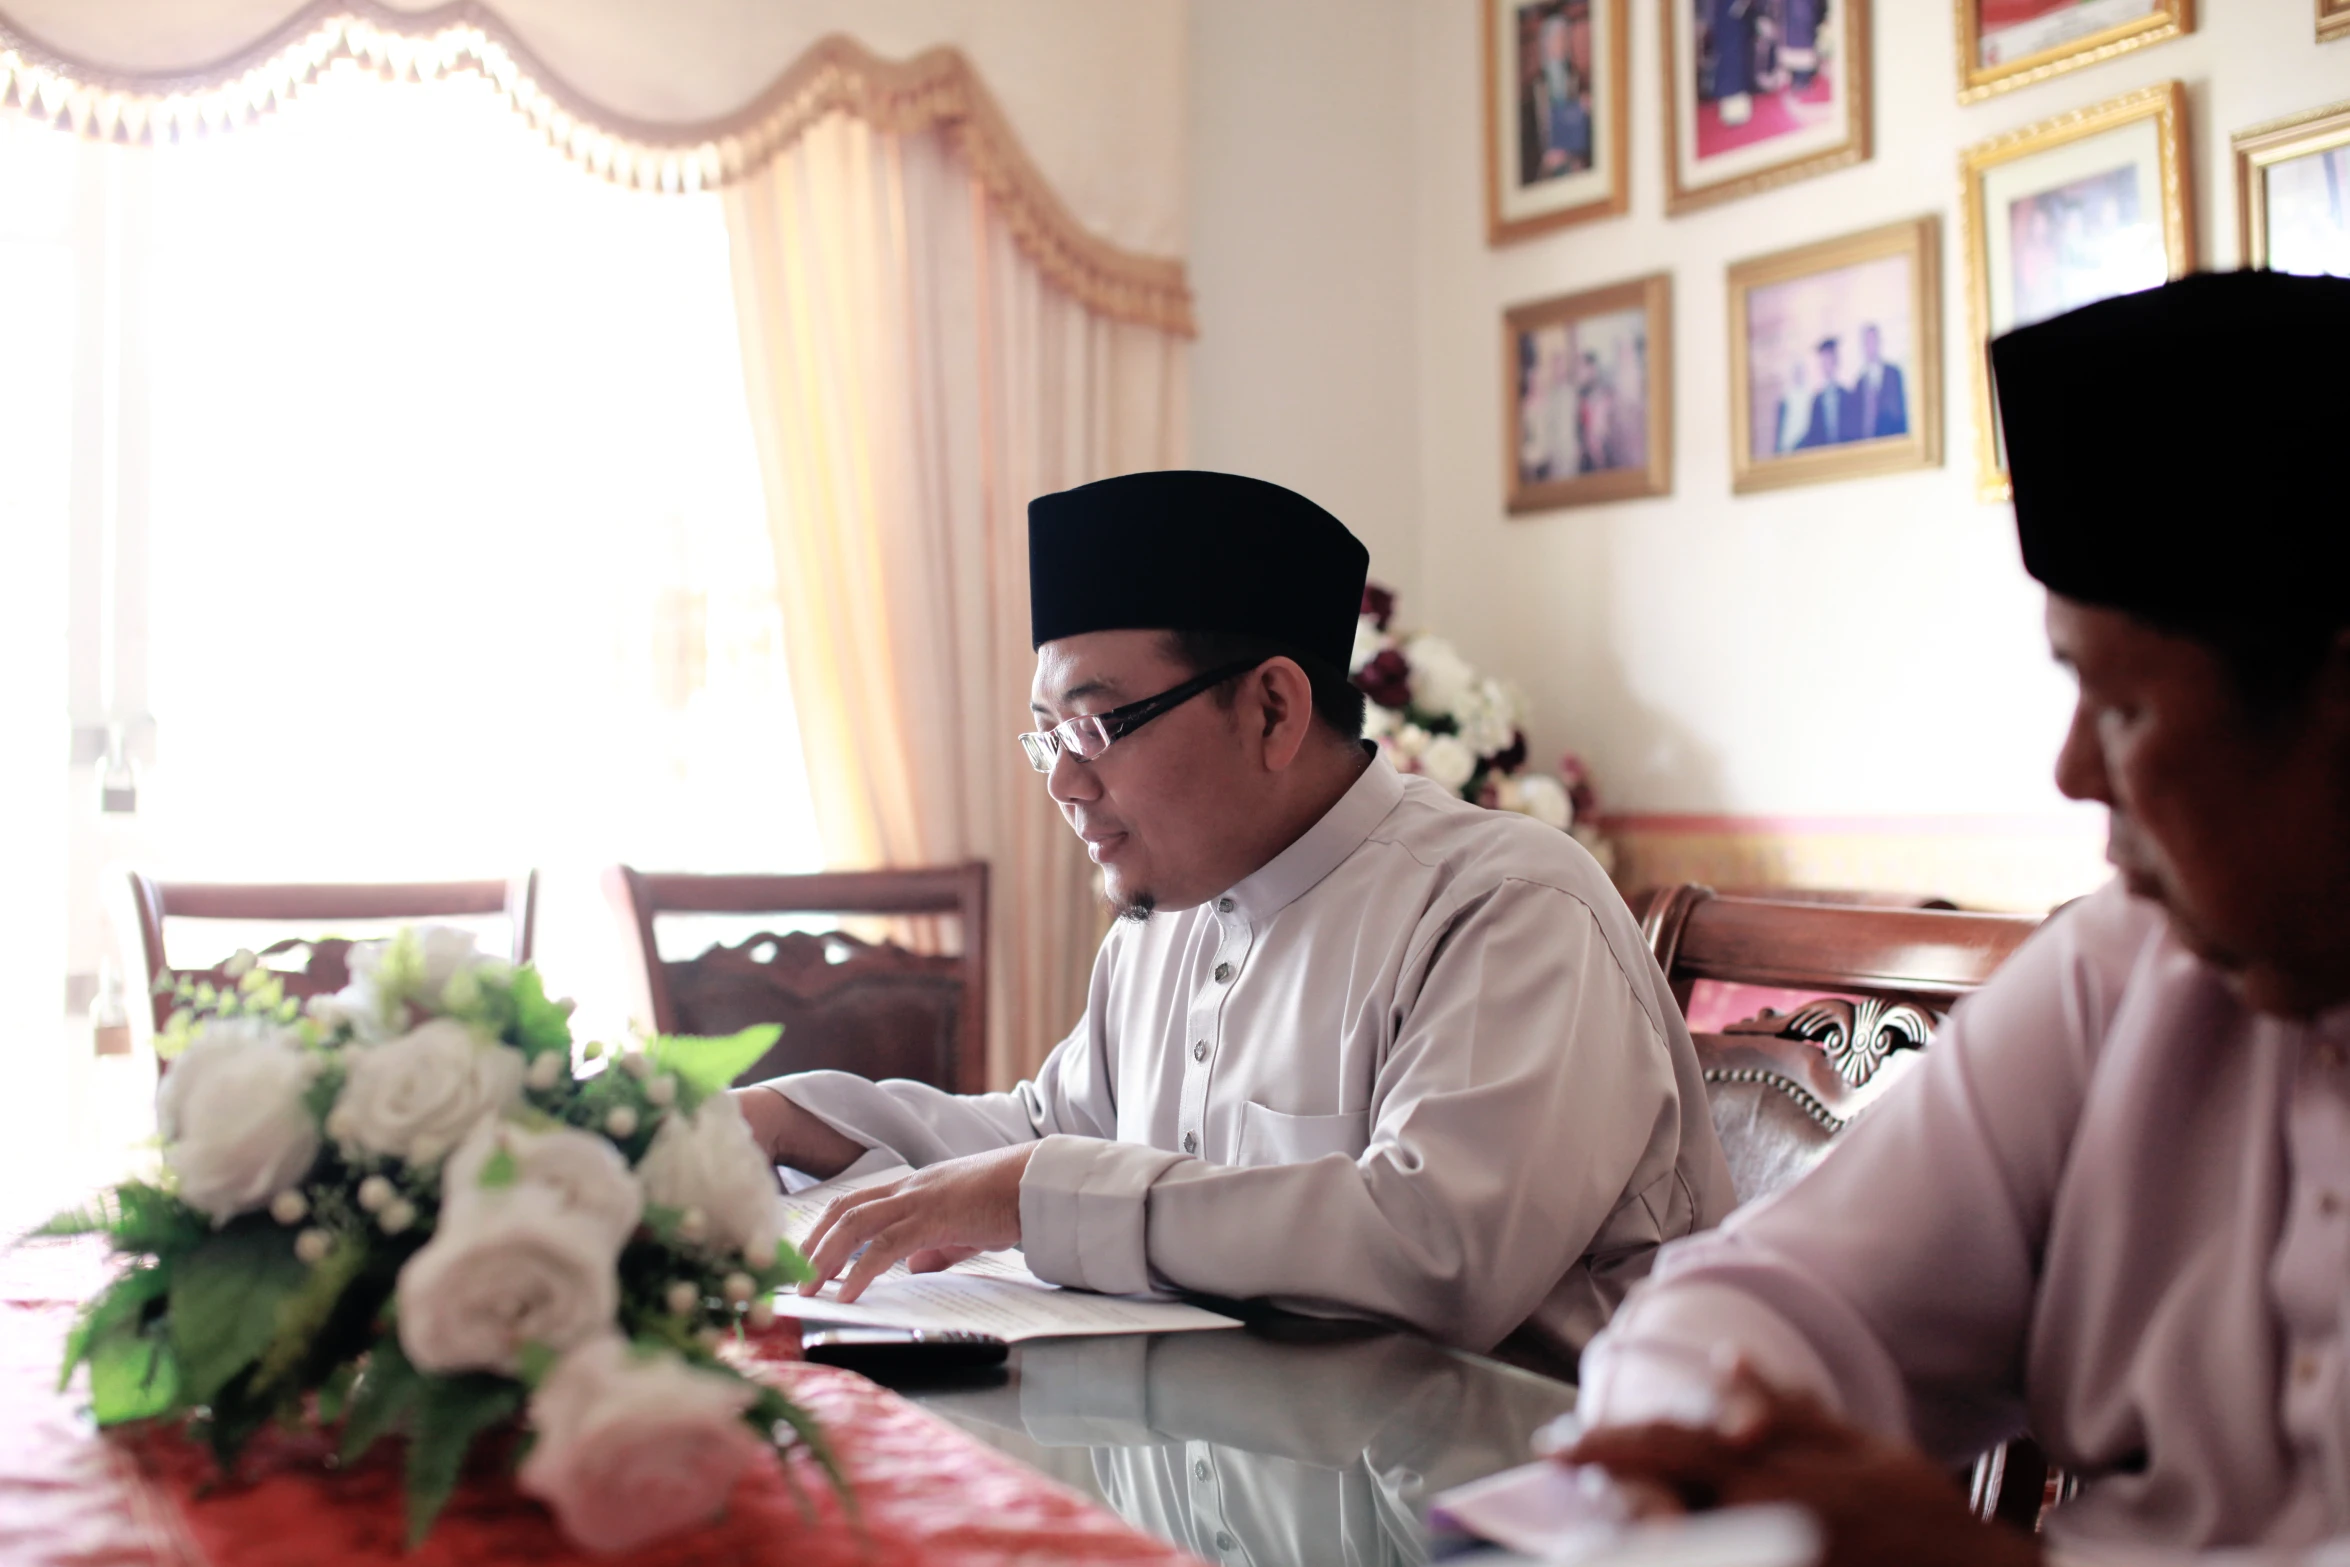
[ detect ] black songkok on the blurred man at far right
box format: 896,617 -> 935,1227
1990,273 -> 2350,630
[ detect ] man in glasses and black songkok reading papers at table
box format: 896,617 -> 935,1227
743,472 -> 1732,1363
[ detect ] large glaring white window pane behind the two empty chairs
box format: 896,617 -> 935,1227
139,73 -> 818,1034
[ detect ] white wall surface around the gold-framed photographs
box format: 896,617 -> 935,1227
1412,0 -> 2350,815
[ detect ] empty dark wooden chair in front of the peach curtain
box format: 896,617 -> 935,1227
604,862 -> 987,1092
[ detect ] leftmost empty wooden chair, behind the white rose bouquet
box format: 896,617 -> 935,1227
132,872 -> 538,1029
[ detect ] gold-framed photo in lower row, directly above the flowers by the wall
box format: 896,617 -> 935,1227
1502,273 -> 1673,512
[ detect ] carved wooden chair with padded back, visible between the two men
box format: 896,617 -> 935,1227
1638,883 -> 2066,1529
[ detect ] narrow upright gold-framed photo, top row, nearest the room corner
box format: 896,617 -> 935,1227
1478,0 -> 1631,244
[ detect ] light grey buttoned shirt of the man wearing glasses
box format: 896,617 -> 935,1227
773,759 -> 1734,1353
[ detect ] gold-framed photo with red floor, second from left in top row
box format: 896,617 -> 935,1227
1657,0 -> 1868,211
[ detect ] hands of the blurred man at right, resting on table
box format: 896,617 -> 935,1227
1558,1365 -> 2040,1567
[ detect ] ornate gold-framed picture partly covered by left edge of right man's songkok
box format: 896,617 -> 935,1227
1960,82 -> 2195,500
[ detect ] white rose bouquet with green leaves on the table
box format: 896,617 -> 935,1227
38,928 -> 839,1551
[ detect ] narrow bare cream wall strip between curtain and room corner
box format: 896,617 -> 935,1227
1189,0 -> 1419,587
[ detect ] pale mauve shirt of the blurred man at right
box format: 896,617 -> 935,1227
1584,886 -> 2350,1562
